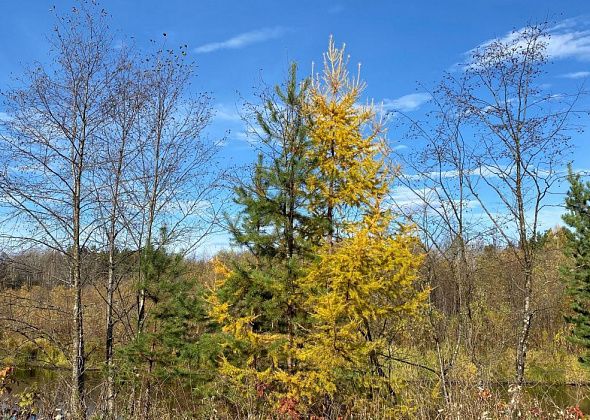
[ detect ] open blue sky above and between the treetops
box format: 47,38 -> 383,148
0,0 -> 590,253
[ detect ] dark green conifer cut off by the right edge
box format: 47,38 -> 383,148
563,166 -> 590,367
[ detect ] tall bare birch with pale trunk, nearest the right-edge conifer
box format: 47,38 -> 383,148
454,25 -> 580,386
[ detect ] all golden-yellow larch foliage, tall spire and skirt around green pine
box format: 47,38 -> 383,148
209,39 -> 428,409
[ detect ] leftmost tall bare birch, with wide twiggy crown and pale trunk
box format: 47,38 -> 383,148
0,3 -> 119,418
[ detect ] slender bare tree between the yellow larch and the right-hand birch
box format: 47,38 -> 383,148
392,79 -> 480,403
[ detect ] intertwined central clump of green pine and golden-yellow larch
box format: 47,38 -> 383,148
210,40 -> 426,415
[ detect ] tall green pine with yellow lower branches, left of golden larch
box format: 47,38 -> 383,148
211,64 -> 315,406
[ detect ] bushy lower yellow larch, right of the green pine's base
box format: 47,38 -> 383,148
298,213 -> 428,396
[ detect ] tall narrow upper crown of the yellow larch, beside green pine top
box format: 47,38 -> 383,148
306,38 -> 387,244
